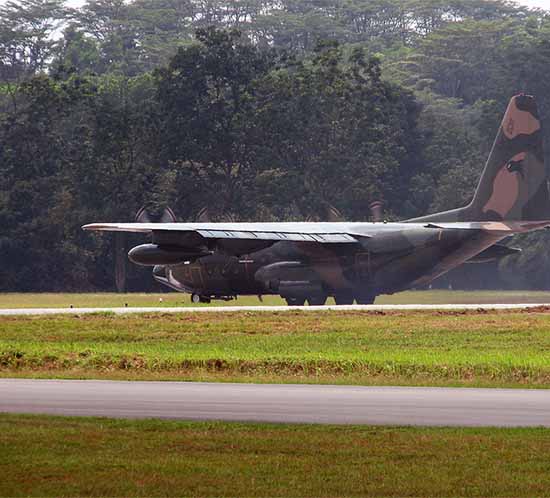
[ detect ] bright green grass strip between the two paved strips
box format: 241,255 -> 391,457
0,310 -> 550,387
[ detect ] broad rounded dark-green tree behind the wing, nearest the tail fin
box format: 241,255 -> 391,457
255,41 -> 418,219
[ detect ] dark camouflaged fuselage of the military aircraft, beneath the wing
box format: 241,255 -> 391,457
154,229 -> 500,303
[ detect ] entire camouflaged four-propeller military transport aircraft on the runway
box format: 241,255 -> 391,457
83,94 -> 550,305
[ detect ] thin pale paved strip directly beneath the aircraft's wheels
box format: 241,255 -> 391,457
0,303 -> 550,316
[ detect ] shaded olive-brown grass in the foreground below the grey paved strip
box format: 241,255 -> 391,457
0,415 -> 550,497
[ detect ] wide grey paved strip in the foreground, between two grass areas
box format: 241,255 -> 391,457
0,379 -> 550,427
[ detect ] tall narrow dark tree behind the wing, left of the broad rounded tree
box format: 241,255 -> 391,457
156,28 -> 269,218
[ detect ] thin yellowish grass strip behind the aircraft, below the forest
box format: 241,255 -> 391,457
0,290 -> 550,308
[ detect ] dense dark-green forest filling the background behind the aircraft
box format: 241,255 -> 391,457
0,0 -> 550,291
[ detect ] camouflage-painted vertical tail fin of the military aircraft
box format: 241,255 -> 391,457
411,94 -> 550,222
